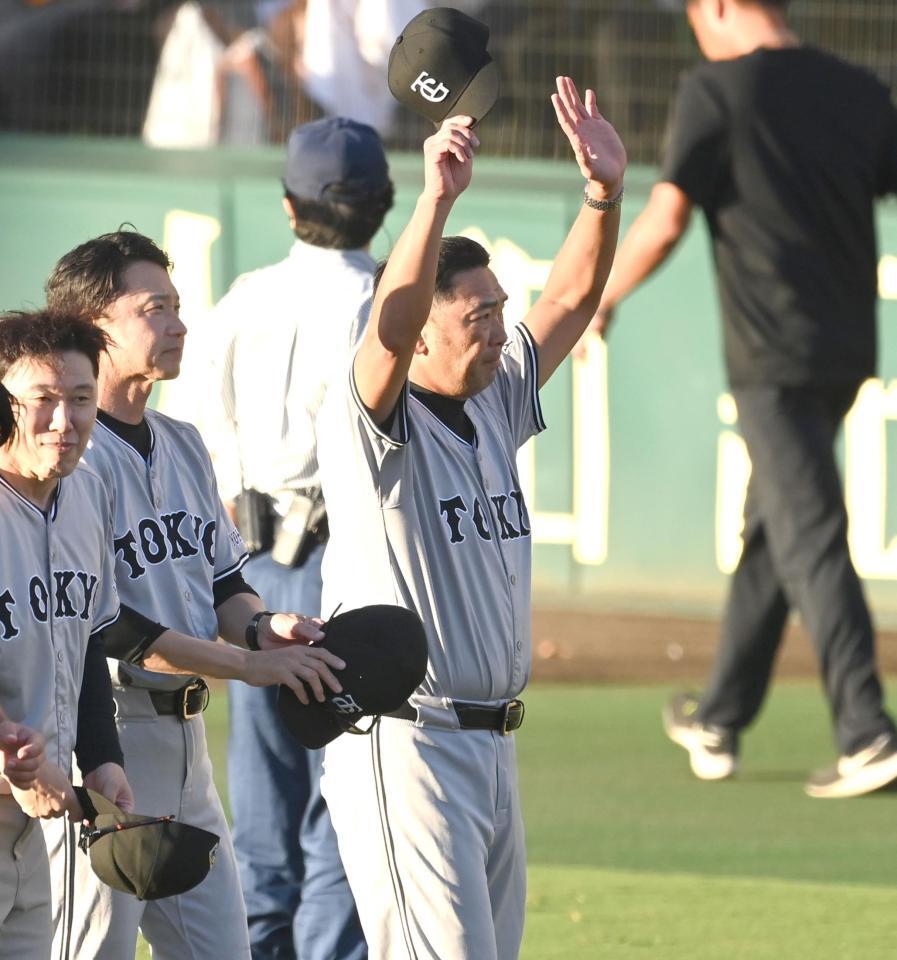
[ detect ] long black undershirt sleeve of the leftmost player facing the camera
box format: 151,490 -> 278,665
75,633 -> 125,774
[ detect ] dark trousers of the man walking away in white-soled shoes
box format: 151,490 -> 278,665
698,384 -> 894,754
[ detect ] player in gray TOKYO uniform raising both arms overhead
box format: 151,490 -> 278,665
318,78 -> 626,960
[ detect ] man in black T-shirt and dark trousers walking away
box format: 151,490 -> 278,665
593,0 -> 897,797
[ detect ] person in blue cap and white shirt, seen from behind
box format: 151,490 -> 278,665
206,117 -> 393,960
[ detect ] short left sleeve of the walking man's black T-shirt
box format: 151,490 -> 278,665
660,71 -> 728,209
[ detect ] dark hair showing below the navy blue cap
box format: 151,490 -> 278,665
285,183 -> 394,250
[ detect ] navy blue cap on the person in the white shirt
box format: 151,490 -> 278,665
283,117 -> 390,201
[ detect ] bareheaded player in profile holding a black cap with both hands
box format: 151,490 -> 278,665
47,231 -> 344,960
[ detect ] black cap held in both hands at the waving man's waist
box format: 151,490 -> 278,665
277,604 -> 427,750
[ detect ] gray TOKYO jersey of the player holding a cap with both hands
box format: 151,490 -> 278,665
84,410 -> 246,689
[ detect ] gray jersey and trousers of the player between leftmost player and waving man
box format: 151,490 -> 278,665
50,410 -> 249,960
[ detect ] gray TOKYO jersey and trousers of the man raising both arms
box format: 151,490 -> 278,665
318,325 -> 544,960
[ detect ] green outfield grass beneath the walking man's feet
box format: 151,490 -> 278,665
138,682 -> 897,960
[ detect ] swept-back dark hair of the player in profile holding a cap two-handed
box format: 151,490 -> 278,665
46,228 -> 171,320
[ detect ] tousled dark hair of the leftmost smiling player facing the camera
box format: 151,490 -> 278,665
0,310 -> 108,378
